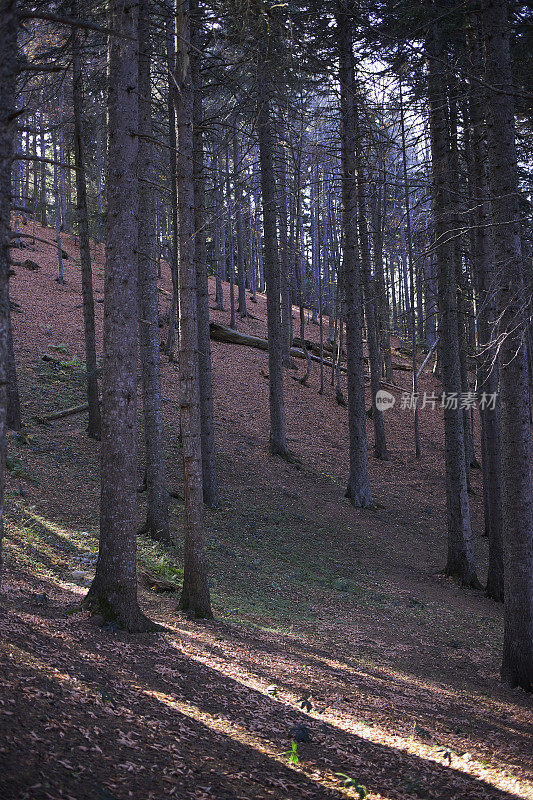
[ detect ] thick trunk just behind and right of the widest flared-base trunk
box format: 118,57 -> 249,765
138,0 -> 172,544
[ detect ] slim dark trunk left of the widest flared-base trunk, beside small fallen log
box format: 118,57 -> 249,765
72,2 -> 101,439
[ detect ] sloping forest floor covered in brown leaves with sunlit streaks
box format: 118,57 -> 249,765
0,219 -> 533,800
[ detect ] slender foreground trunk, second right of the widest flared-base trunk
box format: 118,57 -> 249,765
174,0 -> 213,618
